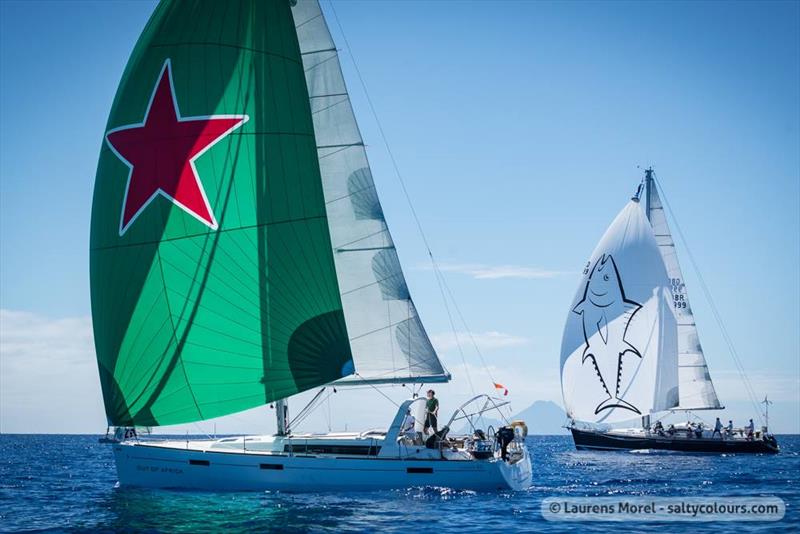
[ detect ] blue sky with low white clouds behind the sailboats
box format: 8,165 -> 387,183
0,0 -> 800,433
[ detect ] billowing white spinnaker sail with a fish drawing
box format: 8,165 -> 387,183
561,201 -> 678,423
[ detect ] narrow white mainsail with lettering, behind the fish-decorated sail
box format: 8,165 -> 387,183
644,178 -> 722,410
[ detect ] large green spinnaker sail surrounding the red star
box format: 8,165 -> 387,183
91,0 -> 353,426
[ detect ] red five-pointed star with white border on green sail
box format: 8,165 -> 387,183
106,59 -> 248,236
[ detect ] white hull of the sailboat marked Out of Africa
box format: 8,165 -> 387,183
113,442 -> 532,492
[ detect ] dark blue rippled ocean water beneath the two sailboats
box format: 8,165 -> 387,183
0,435 -> 800,534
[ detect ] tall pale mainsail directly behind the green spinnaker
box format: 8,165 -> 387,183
292,0 -> 450,384
